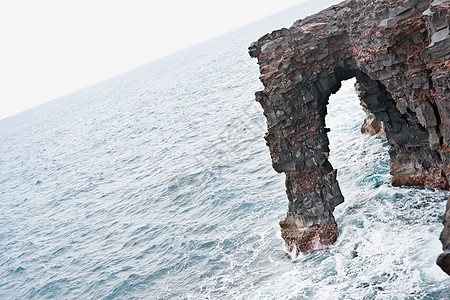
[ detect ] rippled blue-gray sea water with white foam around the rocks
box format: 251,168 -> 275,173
0,0 -> 450,299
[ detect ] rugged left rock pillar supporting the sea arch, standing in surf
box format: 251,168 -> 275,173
257,72 -> 343,253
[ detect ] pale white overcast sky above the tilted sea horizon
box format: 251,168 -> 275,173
0,0 -> 304,119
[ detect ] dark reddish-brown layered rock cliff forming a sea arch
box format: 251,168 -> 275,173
249,0 -> 450,271
